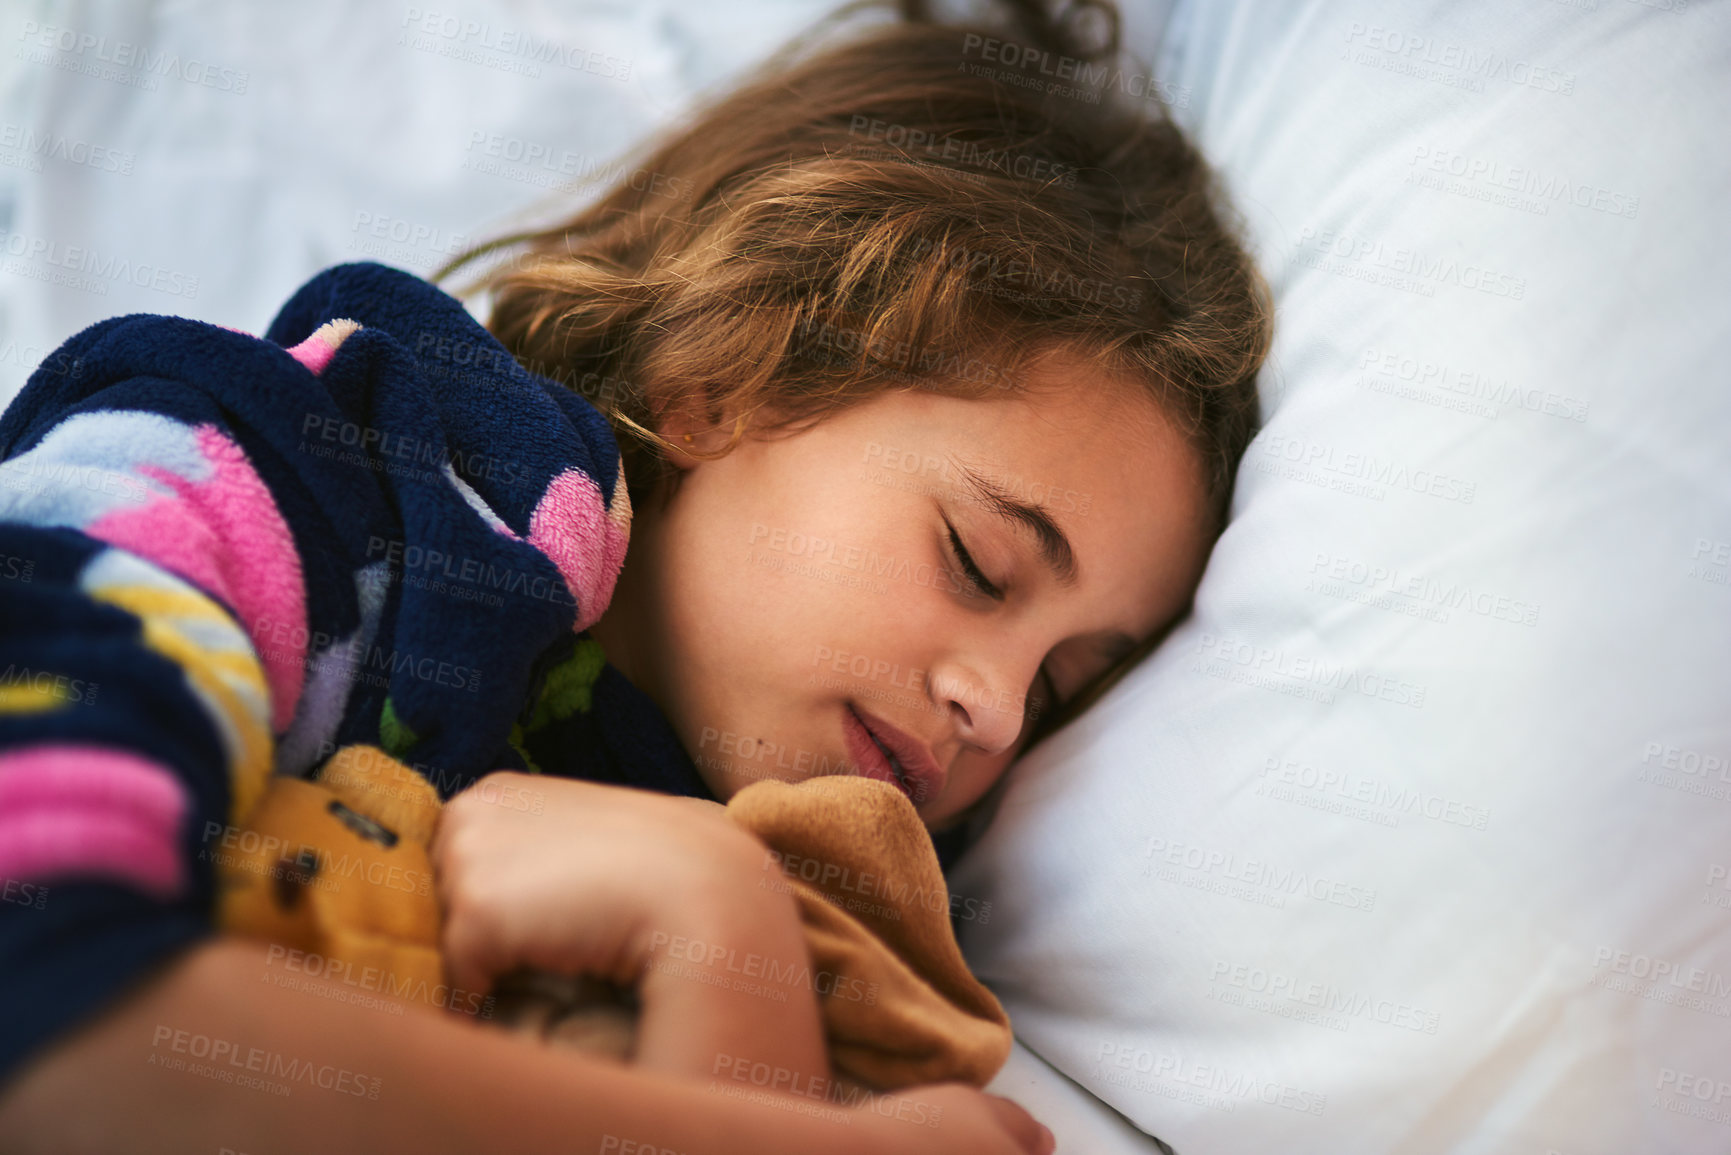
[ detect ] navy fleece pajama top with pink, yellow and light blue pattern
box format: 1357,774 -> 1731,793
0,265 -> 710,1079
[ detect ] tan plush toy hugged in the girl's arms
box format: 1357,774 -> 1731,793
218,746 -> 1011,1091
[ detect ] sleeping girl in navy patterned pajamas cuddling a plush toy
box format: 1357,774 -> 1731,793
0,3 -> 1269,1155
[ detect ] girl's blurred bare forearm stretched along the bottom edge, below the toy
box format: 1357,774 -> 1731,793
0,940 -> 1049,1155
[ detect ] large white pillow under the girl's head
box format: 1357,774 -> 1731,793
956,0 -> 1731,1155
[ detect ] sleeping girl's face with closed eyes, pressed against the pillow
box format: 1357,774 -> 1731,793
595,357 -> 1207,828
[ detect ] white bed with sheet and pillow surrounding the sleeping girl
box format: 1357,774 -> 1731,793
0,0 -> 1731,1155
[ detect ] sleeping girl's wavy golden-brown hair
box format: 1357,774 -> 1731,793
438,0 -> 1271,526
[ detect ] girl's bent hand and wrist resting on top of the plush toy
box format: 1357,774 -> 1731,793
431,772 -> 829,1077
